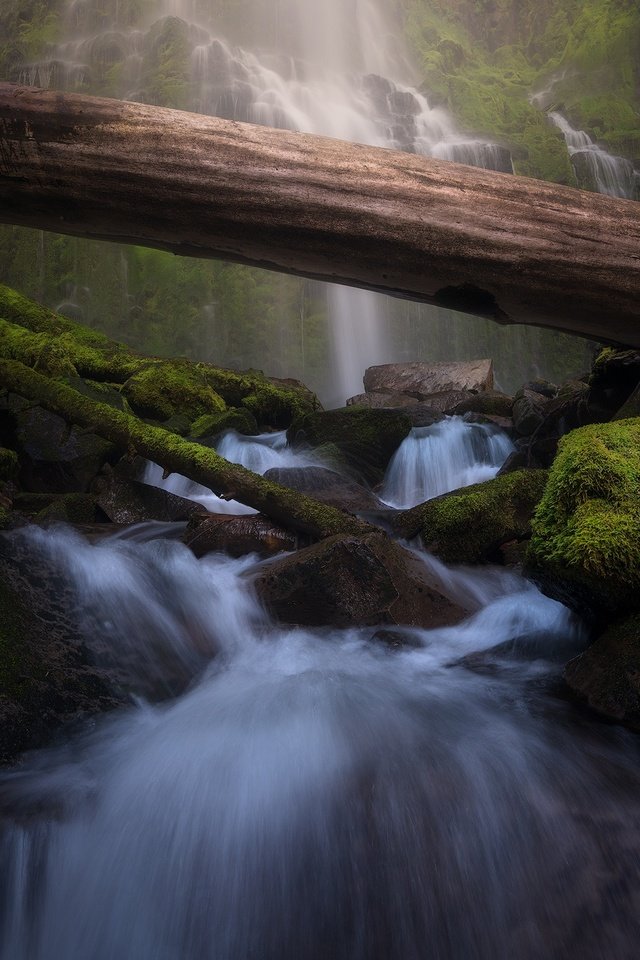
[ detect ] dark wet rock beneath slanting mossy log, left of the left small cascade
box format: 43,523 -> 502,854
93,471 -> 203,523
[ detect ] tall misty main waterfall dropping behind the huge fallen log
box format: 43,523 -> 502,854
20,0 -> 512,404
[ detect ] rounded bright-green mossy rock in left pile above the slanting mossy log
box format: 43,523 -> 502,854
122,360 -> 226,421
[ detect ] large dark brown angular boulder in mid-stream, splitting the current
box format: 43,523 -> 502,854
256,533 -> 466,628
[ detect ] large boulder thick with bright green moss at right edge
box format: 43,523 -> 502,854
528,419 -> 640,617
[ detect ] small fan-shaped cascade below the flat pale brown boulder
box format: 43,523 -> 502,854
380,417 -> 514,509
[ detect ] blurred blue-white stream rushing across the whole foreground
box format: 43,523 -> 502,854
0,425 -> 640,960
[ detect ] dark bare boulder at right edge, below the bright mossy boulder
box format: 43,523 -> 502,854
565,614 -> 640,731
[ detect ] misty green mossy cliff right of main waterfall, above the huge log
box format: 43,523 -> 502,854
406,0 -> 640,184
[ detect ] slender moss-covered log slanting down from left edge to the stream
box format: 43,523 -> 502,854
0,360 -> 371,539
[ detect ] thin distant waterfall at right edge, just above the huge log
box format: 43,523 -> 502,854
548,110 -> 640,200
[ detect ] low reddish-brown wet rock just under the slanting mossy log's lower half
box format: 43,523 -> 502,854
182,514 -> 299,557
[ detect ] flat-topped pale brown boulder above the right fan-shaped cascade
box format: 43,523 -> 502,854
364,360 -> 493,400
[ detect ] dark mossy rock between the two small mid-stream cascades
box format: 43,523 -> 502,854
287,405 -> 411,484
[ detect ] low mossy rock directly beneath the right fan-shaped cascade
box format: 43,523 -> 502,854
394,470 -> 548,563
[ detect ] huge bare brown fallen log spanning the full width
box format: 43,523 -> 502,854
0,84 -> 640,346
